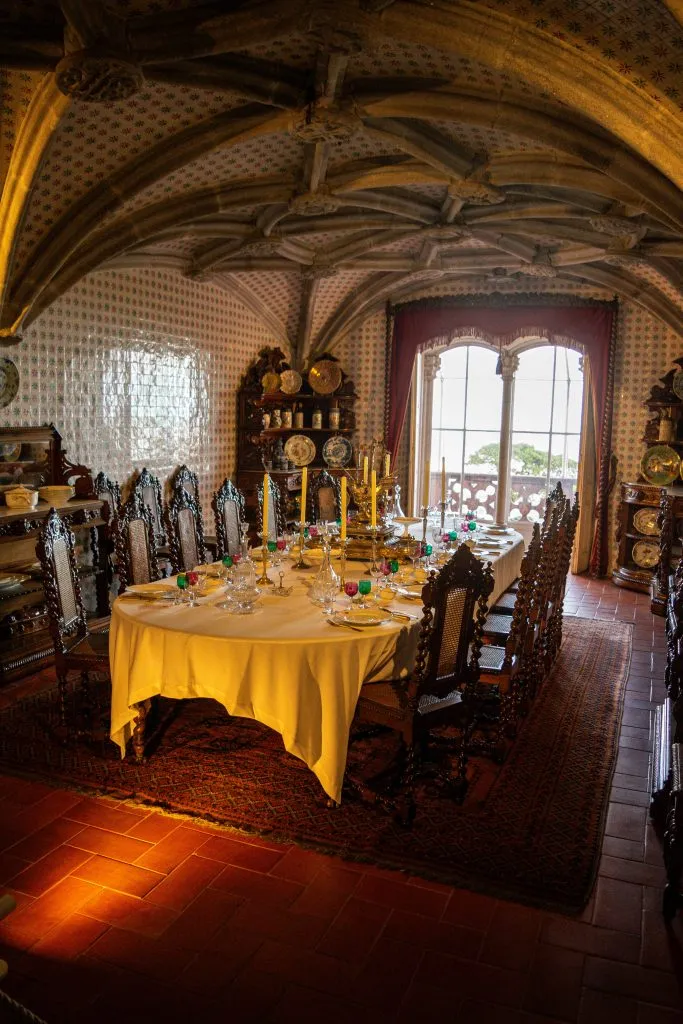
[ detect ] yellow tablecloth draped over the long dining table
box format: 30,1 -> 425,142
110,535 -> 523,802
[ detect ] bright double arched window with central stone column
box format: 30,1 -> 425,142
413,339 -> 584,524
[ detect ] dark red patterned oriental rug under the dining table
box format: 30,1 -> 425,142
0,618 -> 631,911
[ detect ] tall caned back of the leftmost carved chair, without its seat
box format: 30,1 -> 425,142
36,509 -> 88,653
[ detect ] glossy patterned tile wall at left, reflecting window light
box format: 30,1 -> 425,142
0,269 -> 272,507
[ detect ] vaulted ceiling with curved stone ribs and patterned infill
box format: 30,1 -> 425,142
0,0 -> 683,362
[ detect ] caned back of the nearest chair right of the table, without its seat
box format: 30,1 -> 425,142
409,545 -> 494,699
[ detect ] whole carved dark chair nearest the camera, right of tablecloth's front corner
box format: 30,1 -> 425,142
348,545 -> 494,823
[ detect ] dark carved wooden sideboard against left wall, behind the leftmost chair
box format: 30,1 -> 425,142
0,426 -> 109,683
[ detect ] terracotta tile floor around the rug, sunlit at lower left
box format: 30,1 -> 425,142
0,580 -> 683,1024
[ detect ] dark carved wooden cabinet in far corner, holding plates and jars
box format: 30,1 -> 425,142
237,348 -> 357,526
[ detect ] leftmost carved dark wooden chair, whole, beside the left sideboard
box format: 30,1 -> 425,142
36,509 -> 109,724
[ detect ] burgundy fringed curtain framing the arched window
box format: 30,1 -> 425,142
387,302 -> 616,575
